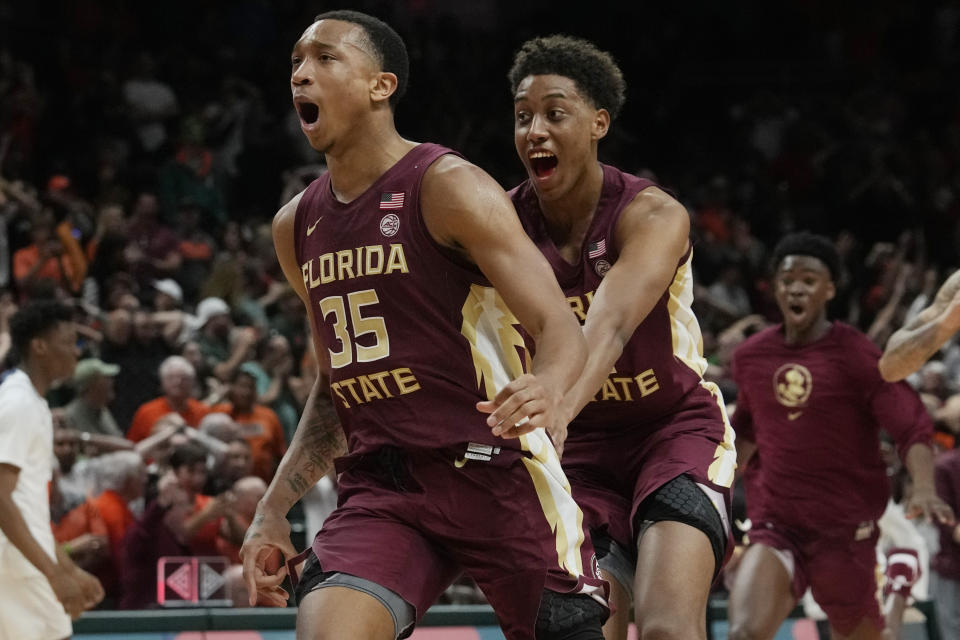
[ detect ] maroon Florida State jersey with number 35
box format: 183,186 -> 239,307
295,143 -> 526,460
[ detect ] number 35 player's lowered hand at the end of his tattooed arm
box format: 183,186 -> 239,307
240,509 -> 297,607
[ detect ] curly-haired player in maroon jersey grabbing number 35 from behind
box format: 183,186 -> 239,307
507,36 -> 736,640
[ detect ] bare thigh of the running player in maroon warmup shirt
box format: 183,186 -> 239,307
729,544 -> 797,640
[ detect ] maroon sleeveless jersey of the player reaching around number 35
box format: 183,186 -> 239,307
510,165 -> 722,439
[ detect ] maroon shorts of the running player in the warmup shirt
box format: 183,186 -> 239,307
748,520 -> 884,635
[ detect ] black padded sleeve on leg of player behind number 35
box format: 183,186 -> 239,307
633,475 -> 728,576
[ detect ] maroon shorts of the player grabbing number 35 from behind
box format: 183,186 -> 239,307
563,385 -> 737,572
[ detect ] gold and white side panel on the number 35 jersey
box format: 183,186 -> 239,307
460,284 -> 526,400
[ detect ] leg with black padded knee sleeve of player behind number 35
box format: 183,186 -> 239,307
633,475 -> 729,640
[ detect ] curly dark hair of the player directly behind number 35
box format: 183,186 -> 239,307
507,35 -> 627,120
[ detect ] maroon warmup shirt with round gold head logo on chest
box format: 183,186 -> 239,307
732,322 -> 933,532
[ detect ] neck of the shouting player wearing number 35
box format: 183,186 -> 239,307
325,125 -> 417,203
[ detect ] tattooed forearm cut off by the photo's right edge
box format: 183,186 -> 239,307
879,271 -> 960,382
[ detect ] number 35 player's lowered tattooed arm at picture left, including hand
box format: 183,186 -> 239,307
240,194 -> 347,607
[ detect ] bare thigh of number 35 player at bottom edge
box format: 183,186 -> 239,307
297,586 -> 398,640
